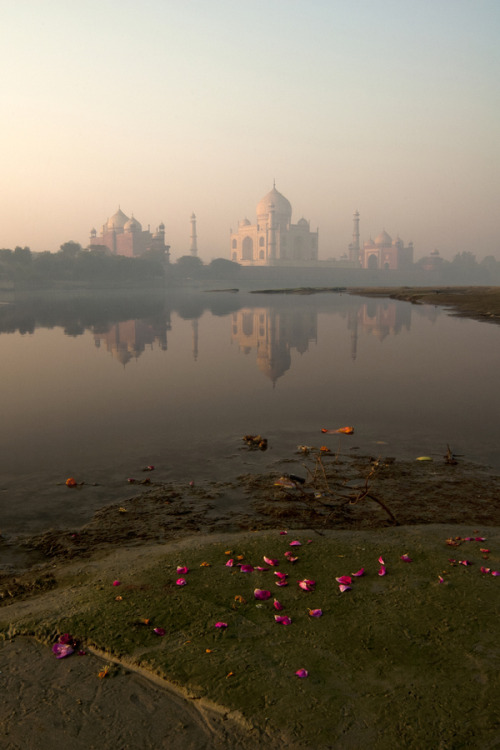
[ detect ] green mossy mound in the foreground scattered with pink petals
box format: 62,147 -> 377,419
3,526 -> 500,750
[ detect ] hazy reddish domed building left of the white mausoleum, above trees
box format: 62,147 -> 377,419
89,208 -> 170,262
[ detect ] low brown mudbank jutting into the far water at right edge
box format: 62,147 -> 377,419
348,286 -> 500,323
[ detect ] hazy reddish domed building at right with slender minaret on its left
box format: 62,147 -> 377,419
349,211 -> 413,271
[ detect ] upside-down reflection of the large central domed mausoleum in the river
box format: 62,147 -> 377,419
231,307 -> 317,386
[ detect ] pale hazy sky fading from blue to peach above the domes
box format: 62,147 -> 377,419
0,0 -> 500,262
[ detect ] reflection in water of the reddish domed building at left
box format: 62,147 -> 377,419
94,315 -> 171,366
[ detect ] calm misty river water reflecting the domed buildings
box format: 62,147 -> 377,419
0,293 -> 500,533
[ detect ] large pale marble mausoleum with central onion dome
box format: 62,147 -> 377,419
230,185 -> 318,266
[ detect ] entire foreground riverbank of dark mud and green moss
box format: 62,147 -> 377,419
0,453 -> 500,750
